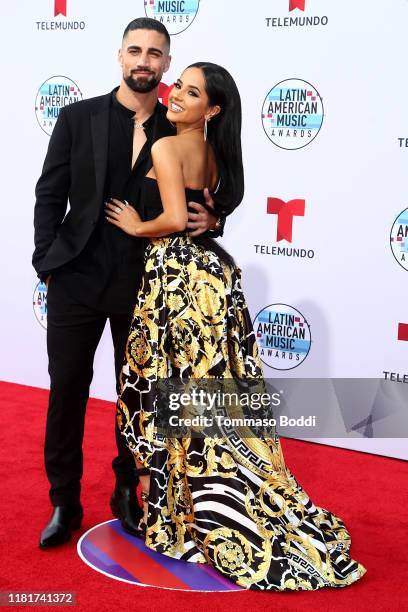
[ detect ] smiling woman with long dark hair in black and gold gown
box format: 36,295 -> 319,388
106,63 -> 366,591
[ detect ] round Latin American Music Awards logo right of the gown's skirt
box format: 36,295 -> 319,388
254,304 -> 312,370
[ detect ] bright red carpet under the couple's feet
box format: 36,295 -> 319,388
0,383 -> 408,612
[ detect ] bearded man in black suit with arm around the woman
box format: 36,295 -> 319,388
33,18 -> 223,549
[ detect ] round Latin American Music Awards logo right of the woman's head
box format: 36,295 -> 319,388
262,79 -> 324,150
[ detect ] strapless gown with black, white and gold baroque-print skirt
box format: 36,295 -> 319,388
117,177 -> 366,591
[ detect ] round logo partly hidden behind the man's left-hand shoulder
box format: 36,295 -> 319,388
35,75 -> 82,136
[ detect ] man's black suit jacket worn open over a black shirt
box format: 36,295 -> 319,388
33,93 -> 175,279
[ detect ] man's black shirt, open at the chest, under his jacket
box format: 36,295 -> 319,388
54,91 -> 157,313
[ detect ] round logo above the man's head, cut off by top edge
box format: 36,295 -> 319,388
144,0 -> 200,34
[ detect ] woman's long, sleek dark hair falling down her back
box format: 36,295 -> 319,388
188,62 -> 244,215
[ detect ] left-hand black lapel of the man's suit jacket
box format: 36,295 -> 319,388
91,94 -> 111,201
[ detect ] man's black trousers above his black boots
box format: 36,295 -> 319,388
44,274 -> 135,506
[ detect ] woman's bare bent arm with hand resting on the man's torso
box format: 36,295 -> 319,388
107,136 -> 187,238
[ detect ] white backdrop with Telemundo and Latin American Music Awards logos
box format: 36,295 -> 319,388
0,0 -> 408,458
